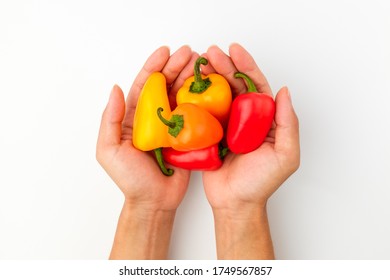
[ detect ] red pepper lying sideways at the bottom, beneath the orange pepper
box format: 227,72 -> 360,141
162,144 -> 227,171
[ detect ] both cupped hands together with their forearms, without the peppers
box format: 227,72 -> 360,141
96,44 -> 300,259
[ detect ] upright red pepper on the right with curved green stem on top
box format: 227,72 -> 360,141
226,72 -> 275,154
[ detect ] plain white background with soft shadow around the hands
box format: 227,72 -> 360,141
0,0 -> 390,259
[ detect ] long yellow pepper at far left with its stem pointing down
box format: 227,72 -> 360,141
132,72 -> 173,176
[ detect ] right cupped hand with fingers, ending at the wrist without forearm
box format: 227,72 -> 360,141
203,44 -> 300,215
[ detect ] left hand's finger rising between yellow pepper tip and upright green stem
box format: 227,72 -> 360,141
162,46 -> 192,85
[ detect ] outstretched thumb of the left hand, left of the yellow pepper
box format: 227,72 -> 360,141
97,85 -> 125,151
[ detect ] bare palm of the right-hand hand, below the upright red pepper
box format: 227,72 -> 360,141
203,138 -> 281,208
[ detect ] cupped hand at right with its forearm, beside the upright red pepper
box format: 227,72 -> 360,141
203,44 -> 300,258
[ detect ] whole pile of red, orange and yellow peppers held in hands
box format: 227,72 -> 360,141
133,57 -> 275,176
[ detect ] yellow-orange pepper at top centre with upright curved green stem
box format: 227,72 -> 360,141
176,57 -> 232,127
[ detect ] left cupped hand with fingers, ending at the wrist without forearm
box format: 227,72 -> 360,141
96,46 -> 196,210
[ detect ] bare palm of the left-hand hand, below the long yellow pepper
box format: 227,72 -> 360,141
106,139 -> 189,210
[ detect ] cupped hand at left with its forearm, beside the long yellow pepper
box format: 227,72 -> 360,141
96,46 -> 196,258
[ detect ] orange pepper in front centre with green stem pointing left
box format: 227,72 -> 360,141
157,103 -> 223,151
